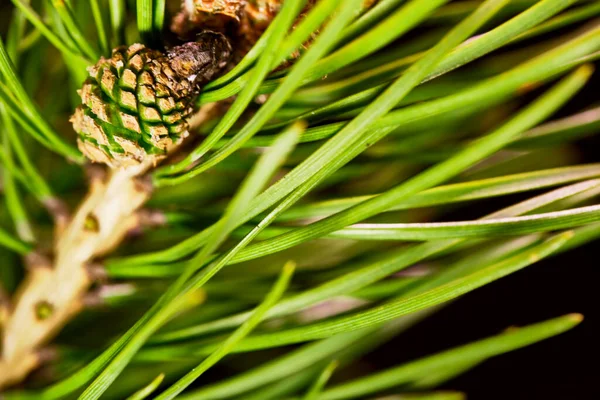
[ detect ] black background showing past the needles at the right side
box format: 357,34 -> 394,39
367,68 -> 600,400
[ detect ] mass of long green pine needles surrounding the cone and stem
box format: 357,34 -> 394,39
0,0 -> 600,400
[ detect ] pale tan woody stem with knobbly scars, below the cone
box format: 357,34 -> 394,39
0,164 -> 152,388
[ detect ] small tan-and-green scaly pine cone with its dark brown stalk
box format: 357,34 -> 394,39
71,31 -> 231,168
